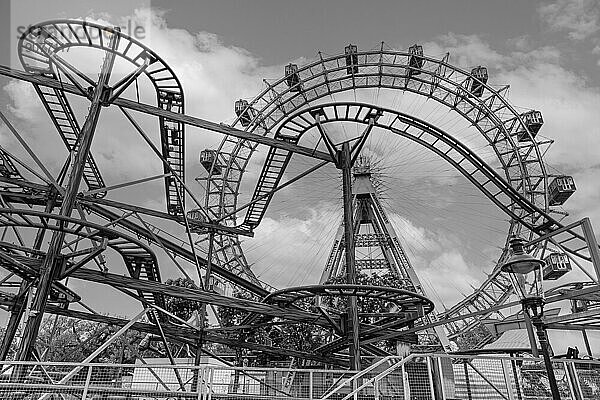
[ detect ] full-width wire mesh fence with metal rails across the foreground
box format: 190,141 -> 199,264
0,354 -> 600,400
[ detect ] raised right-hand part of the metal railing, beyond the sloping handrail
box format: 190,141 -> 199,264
328,354 -> 600,400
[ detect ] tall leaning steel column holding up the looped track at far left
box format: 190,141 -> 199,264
18,28 -> 119,361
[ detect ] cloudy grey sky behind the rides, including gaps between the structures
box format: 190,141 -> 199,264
0,0 -> 600,350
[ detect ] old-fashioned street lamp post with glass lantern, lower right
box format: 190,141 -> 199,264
500,237 -> 560,400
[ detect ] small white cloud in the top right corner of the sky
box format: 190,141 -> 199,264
538,0 -> 600,40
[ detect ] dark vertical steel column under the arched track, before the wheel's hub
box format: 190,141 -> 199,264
339,142 -> 361,371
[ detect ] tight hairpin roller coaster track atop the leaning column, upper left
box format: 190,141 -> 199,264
18,20 -> 185,216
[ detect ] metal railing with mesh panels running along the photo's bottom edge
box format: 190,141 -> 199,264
0,353 -> 600,400
